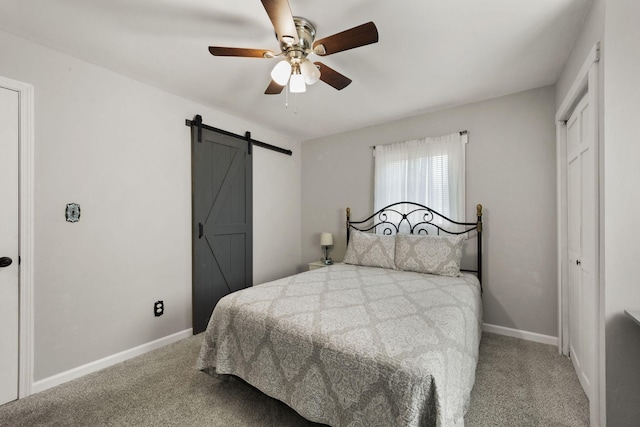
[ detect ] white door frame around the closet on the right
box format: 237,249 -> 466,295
555,43 -> 606,427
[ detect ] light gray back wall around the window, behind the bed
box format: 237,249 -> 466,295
301,86 -> 557,336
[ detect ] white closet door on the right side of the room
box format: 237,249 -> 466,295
567,96 -> 598,399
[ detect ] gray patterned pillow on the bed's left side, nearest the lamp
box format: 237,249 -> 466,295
343,230 -> 396,268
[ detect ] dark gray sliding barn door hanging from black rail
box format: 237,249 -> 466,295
191,123 -> 253,334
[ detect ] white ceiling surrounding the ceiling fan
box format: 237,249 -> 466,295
0,0 -> 591,141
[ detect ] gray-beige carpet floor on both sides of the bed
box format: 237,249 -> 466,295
0,333 -> 589,427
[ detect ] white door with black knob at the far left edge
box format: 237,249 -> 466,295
0,87 -> 19,404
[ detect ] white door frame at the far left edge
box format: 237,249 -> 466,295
0,76 -> 34,399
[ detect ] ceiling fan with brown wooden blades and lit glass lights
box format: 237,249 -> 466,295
209,0 -> 378,95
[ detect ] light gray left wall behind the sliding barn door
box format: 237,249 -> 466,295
0,32 -> 300,381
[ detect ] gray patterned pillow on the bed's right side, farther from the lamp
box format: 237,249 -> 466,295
395,234 -> 465,277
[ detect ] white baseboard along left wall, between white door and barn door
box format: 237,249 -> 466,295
31,329 -> 193,394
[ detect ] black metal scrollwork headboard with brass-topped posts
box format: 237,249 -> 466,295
347,202 -> 482,290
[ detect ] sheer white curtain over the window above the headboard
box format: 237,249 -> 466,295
374,132 -> 467,221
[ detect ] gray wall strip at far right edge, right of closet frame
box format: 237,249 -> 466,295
604,0 -> 640,427
